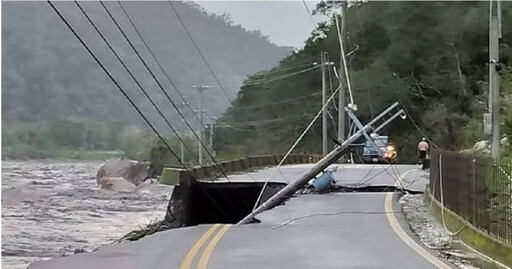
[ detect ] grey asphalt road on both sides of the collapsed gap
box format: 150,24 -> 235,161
30,165 -> 450,269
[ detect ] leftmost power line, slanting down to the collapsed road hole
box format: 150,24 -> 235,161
47,1 -> 231,219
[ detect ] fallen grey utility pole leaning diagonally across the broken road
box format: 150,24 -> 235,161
238,103 -> 404,224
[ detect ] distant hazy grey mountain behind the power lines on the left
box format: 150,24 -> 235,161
2,1 -> 290,123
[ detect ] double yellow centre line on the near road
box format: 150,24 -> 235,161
180,224 -> 231,269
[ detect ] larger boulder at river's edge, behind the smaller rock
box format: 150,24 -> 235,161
96,160 -> 155,186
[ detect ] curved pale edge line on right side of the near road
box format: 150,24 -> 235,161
384,192 -> 452,269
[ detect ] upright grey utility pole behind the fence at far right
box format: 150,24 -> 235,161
489,0 -> 501,159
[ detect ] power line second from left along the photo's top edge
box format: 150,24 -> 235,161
74,1 -> 198,165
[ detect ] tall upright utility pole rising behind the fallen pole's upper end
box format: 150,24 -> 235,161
338,1 -> 347,141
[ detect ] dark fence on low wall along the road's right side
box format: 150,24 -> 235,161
429,150 -> 512,244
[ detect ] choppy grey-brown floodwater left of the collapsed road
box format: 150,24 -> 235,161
2,160 -> 172,268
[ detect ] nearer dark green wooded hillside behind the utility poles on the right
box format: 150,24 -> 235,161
216,1 -> 512,160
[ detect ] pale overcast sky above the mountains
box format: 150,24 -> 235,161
195,1 -> 323,48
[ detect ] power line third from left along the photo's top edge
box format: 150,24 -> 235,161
100,1 -> 229,181
